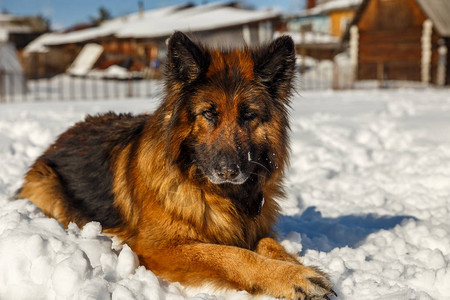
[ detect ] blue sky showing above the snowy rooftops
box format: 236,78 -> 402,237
0,0 -> 304,29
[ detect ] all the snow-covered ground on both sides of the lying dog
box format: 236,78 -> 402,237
0,89 -> 450,300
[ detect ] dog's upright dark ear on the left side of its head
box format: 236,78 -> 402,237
167,31 -> 210,83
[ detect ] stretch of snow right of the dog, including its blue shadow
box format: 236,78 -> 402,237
279,90 -> 450,299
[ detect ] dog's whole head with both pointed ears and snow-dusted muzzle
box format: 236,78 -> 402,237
166,32 -> 295,190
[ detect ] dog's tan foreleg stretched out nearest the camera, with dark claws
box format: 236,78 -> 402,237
138,243 -> 334,300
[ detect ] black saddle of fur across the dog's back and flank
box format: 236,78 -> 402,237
40,113 -> 148,228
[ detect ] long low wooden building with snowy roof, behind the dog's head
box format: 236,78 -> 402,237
22,1 -> 281,77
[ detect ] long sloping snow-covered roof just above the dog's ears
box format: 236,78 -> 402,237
26,2 -> 280,52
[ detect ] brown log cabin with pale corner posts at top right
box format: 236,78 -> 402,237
345,0 -> 450,85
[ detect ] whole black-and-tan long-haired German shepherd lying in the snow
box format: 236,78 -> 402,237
18,32 -> 335,299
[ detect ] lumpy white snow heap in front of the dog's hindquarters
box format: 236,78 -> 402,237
0,200 -> 216,300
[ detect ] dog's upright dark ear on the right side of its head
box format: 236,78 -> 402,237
253,36 -> 295,100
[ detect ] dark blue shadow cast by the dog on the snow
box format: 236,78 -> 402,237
276,206 -> 415,254
